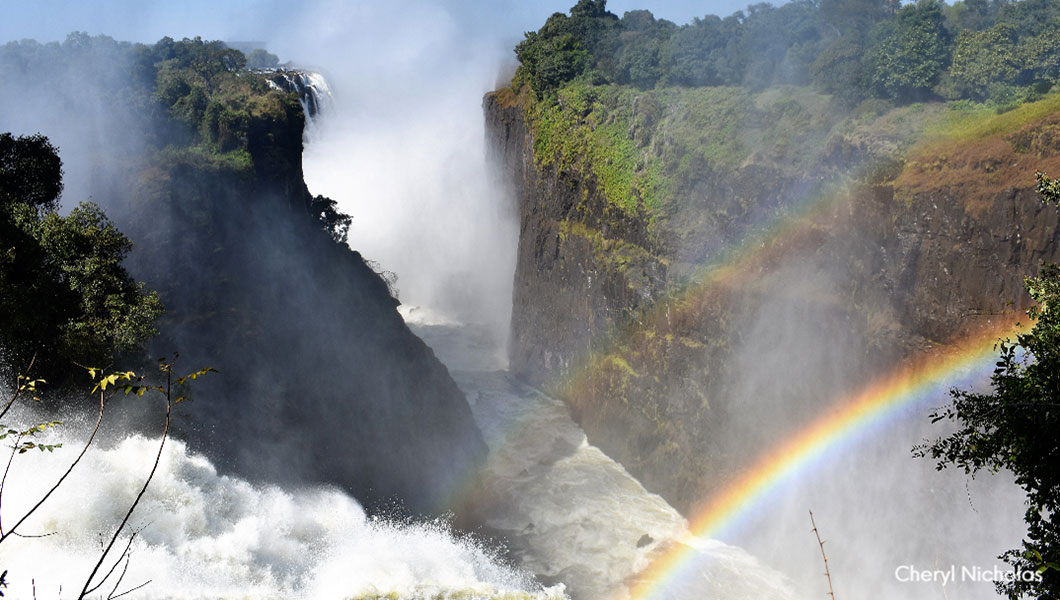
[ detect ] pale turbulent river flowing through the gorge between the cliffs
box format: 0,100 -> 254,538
402,307 -> 796,600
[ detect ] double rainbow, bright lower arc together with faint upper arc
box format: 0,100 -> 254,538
440,148 -> 1043,600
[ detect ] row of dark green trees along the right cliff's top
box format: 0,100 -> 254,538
515,0 -> 1060,105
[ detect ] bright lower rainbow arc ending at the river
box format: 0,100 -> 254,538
630,317 -> 1029,600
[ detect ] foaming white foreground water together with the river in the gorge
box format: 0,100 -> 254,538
0,310 -> 795,600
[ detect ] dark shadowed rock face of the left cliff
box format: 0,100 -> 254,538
125,85 -> 485,521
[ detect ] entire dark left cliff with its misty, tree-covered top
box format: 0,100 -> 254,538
0,34 -> 485,514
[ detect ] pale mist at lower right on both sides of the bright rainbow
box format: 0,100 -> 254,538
721,265 -> 1025,600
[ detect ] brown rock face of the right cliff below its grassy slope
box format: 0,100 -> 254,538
484,90 -> 1060,511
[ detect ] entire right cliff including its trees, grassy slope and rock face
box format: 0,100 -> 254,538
496,0 -> 1060,521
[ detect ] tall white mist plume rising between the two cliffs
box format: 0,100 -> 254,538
290,5 -> 517,347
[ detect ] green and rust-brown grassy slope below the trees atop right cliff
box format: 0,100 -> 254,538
515,77 -> 1060,246
